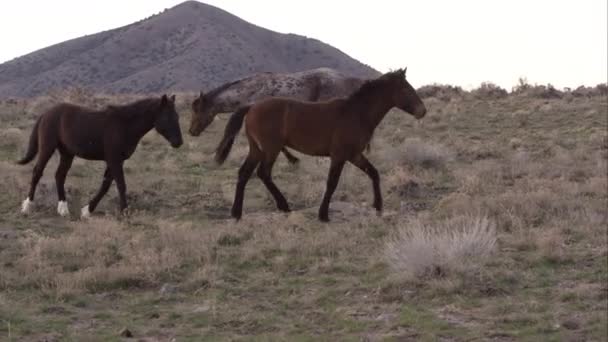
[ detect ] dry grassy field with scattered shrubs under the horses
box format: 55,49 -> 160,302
0,85 -> 608,341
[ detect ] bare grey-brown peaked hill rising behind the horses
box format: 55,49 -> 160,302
0,1 -> 378,98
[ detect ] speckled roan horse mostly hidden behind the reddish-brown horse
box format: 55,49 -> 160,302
188,68 -> 365,164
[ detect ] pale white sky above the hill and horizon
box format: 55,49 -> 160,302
0,0 -> 608,89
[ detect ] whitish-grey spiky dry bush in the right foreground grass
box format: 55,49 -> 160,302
384,215 -> 496,280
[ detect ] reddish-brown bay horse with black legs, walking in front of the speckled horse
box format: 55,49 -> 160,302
215,69 -> 426,222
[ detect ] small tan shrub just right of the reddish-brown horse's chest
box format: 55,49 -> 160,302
399,138 -> 453,169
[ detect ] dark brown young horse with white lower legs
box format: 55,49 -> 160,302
17,95 -> 183,218
